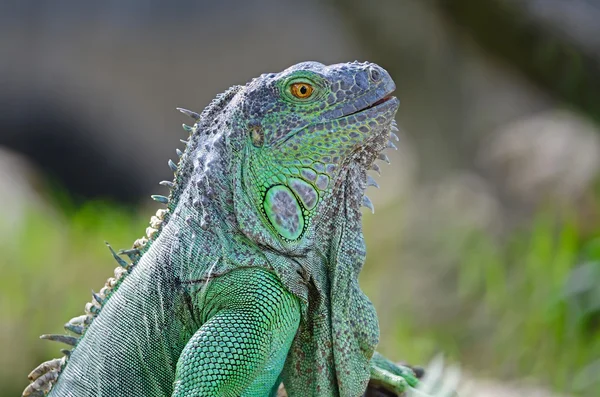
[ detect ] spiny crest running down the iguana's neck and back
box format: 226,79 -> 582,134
23,86 -> 242,397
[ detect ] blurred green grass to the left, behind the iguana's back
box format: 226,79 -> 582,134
0,203 -> 149,396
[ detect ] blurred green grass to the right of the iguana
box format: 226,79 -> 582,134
364,206 -> 600,396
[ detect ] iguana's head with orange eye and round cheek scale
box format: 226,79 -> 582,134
230,62 -> 399,252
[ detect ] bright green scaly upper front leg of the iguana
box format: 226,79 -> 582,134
173,268 -> 300,397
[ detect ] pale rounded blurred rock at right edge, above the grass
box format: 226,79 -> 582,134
479,110 -> 600,205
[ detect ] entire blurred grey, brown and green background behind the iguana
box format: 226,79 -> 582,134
0,0 -> 600,397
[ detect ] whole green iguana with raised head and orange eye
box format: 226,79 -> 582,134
24,62 -> 416,397
